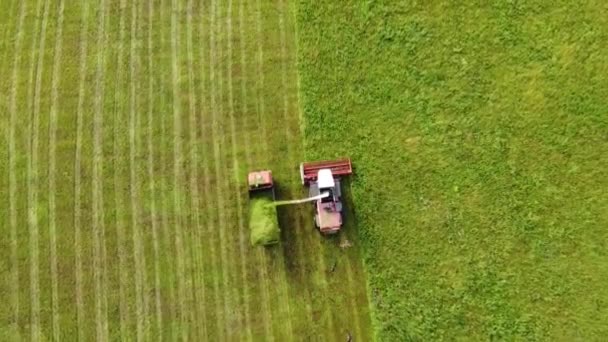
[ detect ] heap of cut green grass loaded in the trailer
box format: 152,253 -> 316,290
249,198 -> 281,246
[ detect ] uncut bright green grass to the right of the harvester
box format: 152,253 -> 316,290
297,0 -> 608,341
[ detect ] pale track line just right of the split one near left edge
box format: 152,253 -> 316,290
48,0 -> 65,341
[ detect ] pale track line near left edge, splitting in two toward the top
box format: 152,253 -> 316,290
27,0 -> 50,340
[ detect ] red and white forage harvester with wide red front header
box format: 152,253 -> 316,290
300,159 -> 353,234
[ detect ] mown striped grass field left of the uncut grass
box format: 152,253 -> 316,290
0,0 -> 372,341
